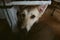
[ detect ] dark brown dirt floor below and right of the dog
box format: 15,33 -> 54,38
0,2 -> 60,40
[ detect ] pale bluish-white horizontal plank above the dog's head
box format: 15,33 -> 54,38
6,1 -> 51,6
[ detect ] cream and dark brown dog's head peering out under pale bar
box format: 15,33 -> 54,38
19,5 -> 47,31
